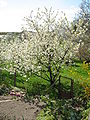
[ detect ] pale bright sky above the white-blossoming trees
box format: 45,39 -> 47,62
0,0 -> 82,32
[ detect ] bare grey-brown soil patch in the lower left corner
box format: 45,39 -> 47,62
0,96 -> 44,120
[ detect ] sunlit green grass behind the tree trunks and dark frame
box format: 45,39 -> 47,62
0,60 -> 90,94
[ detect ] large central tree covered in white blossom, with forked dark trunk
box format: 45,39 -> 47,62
21,9 -> 85,85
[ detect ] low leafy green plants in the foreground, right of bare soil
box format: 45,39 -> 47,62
37,96 -> 83,120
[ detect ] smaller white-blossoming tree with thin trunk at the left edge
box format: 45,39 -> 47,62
0,33 -> 20,86
